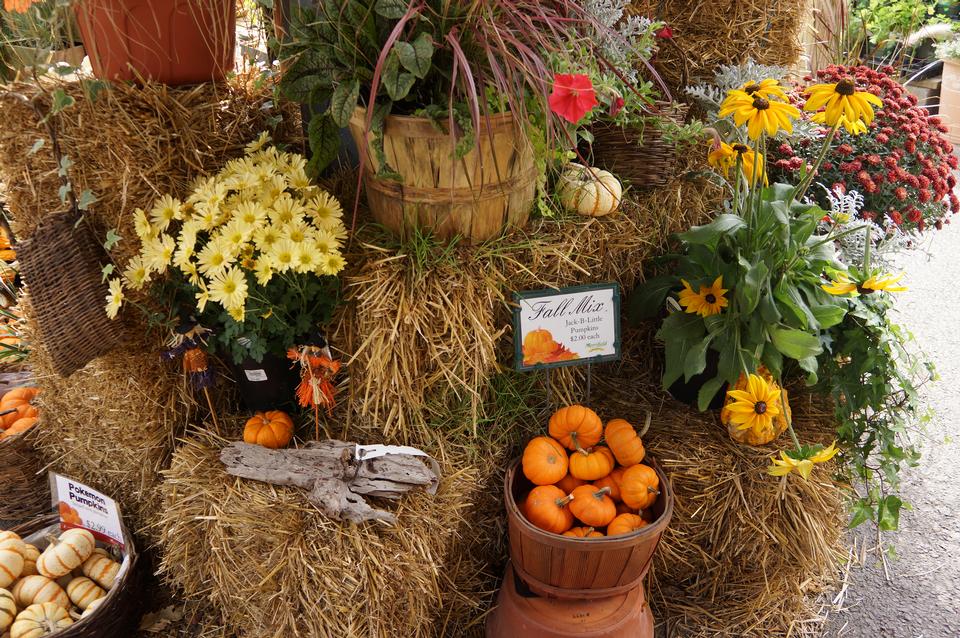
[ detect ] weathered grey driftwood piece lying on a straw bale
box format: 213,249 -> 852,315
220,439 -> 437,524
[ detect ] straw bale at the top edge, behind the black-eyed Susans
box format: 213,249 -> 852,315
631,0 -> 808,91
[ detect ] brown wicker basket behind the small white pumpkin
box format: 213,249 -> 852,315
591,102 -> 689,188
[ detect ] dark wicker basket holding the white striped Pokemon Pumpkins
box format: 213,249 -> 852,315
12,516 -> 144,638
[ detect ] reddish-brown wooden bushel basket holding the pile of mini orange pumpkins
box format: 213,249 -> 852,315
504,457 -> 673,599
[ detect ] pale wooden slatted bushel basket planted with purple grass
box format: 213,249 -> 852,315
350,108 -> 537,243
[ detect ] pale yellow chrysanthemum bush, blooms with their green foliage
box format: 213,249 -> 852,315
106,133 -> 346,410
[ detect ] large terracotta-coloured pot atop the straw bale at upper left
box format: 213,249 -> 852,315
76,0 -> 237,85
